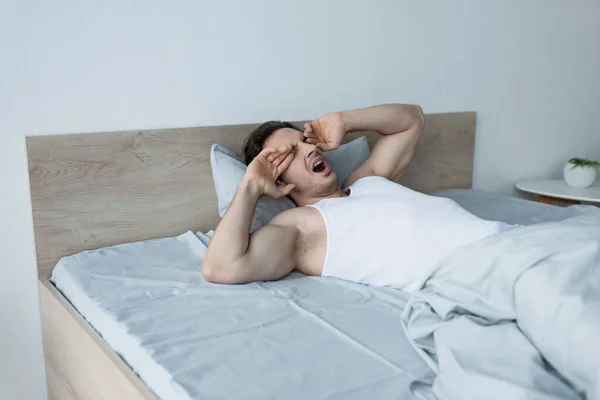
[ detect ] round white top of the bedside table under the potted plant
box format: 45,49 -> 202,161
516,179 -> 600,205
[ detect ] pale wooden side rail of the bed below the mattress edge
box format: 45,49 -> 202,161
39,279 -> 157,400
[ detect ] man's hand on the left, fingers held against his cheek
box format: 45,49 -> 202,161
244,145 -> 296,199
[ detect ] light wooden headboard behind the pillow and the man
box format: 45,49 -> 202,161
26,112 -> 475,279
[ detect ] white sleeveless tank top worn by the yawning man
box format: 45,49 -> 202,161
309,176 -> 511,292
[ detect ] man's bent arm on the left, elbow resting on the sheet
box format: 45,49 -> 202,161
202,147 -> 298,284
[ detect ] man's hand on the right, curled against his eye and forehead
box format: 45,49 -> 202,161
304,112 -> 347,151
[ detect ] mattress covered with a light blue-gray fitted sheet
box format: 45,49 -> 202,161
51,190 -> 591,399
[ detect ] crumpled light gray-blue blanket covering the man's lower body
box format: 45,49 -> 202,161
403,214 -> 600,400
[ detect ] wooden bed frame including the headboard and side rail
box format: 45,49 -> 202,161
26,112 -> 475,400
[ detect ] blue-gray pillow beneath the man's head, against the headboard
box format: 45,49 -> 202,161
210,136 -> 371,232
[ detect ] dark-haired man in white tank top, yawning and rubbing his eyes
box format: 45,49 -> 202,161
202,104 -> 503,291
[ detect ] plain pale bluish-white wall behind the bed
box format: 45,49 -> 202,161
0,0 -> 600,400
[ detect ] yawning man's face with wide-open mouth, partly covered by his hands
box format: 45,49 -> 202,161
264,128 -> 337,204
